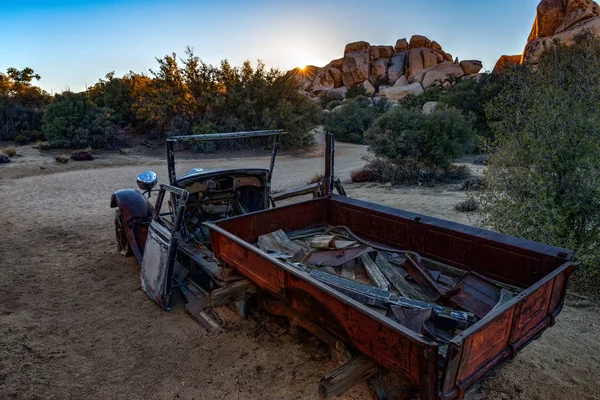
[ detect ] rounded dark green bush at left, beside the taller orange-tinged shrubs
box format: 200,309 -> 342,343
43,92 -> 111,148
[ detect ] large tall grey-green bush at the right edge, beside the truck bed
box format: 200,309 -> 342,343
479,35 -> 600,285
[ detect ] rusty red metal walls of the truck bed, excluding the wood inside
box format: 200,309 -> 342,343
208,195 -> 575,399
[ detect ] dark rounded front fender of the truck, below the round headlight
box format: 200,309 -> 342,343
110,189 -> 154,263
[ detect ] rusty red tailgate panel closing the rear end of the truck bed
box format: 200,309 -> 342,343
442,262 -> 575,399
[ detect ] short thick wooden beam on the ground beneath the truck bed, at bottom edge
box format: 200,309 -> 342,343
319,356 -> 377,399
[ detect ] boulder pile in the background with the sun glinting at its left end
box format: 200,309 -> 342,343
288,35 -> 482,100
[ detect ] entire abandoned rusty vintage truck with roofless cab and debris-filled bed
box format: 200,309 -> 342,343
111,131 -> 576,400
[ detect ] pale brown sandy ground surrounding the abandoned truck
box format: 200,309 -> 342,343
0,144 -> 600,399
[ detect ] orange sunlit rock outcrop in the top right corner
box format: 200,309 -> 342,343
494,0 -> 600,70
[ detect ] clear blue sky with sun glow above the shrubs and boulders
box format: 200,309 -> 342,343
0,0 -> 539,92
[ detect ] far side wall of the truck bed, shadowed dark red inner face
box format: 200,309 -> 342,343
327,195 -> 573,288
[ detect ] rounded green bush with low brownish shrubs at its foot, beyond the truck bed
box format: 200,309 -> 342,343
365,107 -> 475,170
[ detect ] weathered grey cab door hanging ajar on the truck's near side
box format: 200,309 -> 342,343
141,184 -> 188,310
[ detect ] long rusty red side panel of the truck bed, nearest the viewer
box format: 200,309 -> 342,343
211,220 -> 439,400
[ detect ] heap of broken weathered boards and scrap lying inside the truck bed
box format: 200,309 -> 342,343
257,226 -> 518,352
